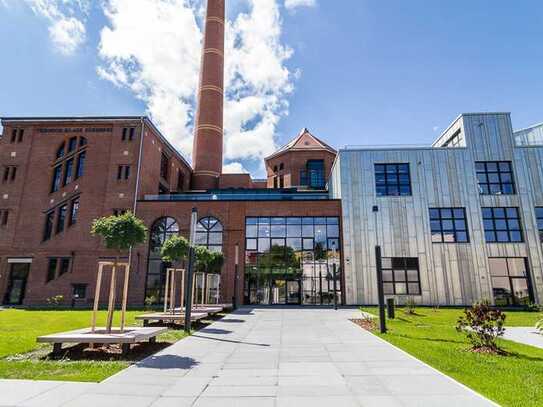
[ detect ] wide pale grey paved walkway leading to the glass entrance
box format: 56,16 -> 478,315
0,308 -> 493,407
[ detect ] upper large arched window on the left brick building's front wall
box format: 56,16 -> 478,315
51,136 -> 87,192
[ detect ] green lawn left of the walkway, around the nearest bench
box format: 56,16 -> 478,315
0,309 -> 191,382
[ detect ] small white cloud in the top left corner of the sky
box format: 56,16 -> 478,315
24,0 -> 90,55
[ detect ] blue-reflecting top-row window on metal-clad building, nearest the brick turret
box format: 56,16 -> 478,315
375,163 -> 411,196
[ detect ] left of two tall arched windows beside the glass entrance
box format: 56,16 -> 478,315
145,217 -> 179,303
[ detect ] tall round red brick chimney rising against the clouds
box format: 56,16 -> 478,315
192,0 -> 225,189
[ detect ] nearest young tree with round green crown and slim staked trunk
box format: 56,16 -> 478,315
91,212 -> 147,332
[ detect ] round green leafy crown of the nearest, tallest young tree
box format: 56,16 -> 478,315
91,212 -> 147,251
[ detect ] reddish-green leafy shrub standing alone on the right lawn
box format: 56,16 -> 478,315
456,301 -> 505,353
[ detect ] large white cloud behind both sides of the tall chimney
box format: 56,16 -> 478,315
98,0 -> 294,175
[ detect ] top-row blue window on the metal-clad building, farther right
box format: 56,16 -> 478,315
475,161 -> 515,195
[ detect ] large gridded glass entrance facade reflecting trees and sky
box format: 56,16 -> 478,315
244,217 -> 342,304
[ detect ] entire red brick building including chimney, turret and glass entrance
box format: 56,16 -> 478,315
0,0 -> 342,306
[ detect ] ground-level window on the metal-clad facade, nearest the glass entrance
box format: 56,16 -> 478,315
382,257 -> 421,295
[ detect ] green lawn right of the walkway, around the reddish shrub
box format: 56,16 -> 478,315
362,307 -> 543,407
